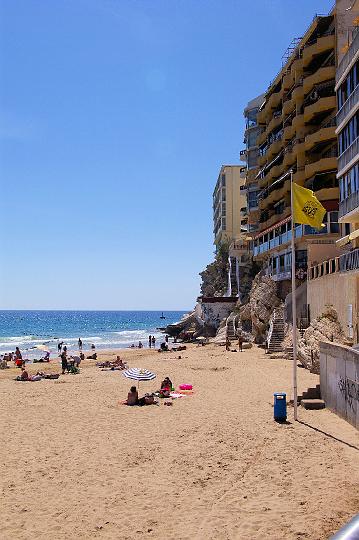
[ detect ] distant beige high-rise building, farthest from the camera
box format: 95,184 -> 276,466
213,165 -> 247,246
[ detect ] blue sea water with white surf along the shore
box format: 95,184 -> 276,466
0,311 -> 186,358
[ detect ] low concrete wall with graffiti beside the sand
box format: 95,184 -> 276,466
320,342 -> 359,429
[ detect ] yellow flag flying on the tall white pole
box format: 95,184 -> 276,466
292,182 -> 326,229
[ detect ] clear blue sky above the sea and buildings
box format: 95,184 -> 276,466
0,0 -> 333,310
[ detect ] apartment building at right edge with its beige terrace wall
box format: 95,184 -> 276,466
308,19 -> 359,343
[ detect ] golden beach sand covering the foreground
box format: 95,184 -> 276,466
0,345 -> 359,540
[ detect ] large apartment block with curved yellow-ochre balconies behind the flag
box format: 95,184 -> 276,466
253,9 -> 346,281
